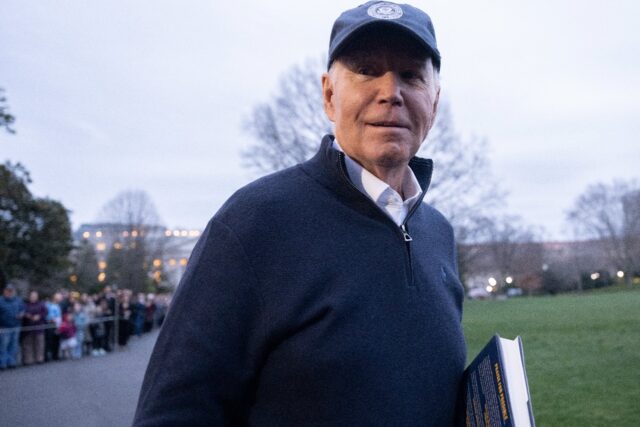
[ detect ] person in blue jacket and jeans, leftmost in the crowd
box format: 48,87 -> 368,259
0,283 -> 24,370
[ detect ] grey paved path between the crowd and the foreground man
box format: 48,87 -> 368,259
0,332 -> 157,427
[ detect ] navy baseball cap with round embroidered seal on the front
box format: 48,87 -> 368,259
328,1 -> 440,70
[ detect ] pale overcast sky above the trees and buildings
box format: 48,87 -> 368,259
0,0 -> 640,239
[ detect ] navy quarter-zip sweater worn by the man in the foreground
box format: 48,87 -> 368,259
134,136 -> 466,426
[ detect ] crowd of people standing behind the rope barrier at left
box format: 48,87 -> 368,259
0,284 -> 170,370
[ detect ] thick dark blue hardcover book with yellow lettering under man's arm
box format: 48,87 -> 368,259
461,334 -> 535,427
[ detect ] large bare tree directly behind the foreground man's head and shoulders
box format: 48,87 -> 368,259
242,57 -> 504,262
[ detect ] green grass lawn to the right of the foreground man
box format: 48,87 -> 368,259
463,290 -> 640,427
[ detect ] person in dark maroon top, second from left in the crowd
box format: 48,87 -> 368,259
22,291 -> 47,365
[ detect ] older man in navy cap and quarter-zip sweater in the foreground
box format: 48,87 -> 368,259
134,2 -> 465,426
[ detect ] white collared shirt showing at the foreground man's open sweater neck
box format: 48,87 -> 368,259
333,139 -> 422,226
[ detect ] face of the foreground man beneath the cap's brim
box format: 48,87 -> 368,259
322,32 -> 440,174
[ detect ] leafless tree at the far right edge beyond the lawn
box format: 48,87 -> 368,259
567,181 -> 640,286
